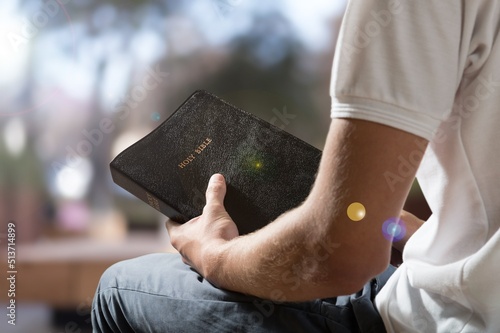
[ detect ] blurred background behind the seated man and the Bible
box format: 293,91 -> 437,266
0,0 -> 428,333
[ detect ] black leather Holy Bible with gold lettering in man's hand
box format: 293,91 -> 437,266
110,91 -> 321,234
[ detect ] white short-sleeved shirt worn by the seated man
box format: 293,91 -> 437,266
331,0 -> 500,333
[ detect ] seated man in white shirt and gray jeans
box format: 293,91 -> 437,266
93,0 -> 500,333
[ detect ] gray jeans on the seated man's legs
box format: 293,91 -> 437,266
92,253 -> 394,333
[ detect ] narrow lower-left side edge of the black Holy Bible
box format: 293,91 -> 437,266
111,165 -> 187,222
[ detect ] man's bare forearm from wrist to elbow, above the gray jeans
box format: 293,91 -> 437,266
204,202 -> 363,301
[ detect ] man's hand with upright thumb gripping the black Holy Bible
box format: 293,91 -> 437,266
167,174 -> 238,276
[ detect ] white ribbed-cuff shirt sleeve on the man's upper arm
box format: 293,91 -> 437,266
330,0 -> 462,140
